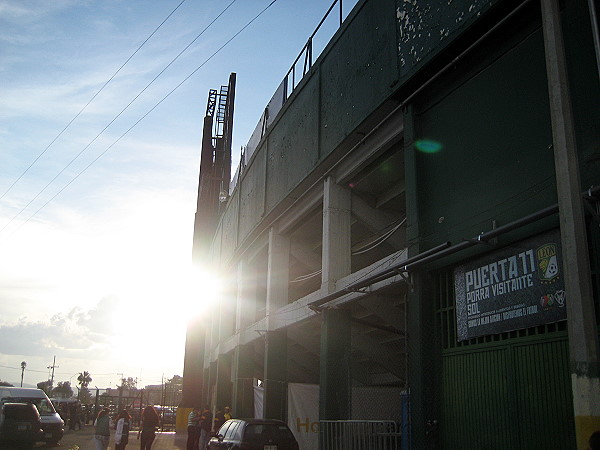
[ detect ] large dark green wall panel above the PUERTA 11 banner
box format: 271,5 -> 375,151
415,25 -> 556,250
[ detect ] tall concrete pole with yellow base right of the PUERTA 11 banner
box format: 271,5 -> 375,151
541,0 -> 600,449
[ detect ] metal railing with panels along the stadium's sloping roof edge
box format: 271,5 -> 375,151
229,0 -> 352,193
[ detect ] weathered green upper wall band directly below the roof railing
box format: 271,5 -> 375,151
213,0 -> 397,259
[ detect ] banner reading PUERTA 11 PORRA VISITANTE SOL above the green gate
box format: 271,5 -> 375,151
454,230 -> 567,341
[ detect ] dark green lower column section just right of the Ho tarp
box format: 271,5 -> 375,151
319,309 -> 352,420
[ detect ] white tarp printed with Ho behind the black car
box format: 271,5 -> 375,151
288,383 -> 319,450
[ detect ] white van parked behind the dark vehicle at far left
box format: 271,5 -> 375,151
0,386 -> 65,445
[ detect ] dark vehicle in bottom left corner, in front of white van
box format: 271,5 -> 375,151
0,403 -> 43,448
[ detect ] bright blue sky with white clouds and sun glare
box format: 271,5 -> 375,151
0,0 -> 355,387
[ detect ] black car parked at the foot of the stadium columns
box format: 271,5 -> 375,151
207,419 -> 298,450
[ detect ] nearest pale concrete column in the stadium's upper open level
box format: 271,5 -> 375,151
321,176 -> 352,293
